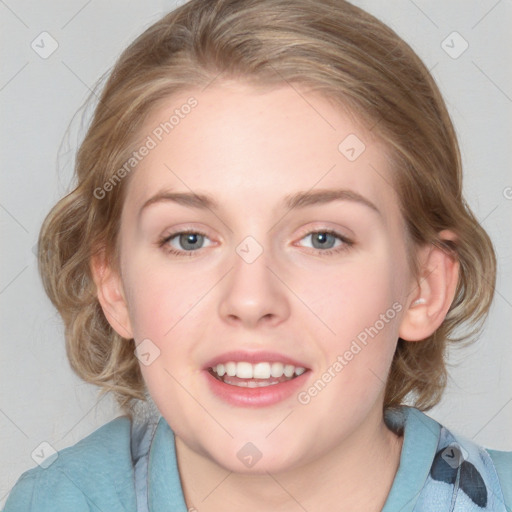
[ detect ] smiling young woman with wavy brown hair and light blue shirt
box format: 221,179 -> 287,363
6,0 -> 512,512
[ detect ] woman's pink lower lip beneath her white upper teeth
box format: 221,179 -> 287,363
203,370 -> 309,407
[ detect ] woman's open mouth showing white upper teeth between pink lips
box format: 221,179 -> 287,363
208,361 -> 307,388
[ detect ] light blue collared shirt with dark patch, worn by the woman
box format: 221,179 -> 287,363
4,406 -> 512,512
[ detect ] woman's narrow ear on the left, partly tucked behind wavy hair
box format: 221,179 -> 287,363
91,251 -> 133,339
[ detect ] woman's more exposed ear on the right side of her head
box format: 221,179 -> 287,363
399,230 -> 459,341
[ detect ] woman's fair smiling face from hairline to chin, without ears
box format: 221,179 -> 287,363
113,82 -> 411,472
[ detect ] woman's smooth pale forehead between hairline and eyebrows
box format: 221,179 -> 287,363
127,82 -> 397,221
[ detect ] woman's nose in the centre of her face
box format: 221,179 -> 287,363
219,240 -> 290,328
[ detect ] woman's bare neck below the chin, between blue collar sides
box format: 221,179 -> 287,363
176,413 -> 403,512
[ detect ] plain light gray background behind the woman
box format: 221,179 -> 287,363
0,0 -> 512,507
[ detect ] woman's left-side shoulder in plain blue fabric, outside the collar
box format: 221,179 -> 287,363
4,416 -> 135,512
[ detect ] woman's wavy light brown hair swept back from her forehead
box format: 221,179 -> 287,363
39,0 -> 496,414
